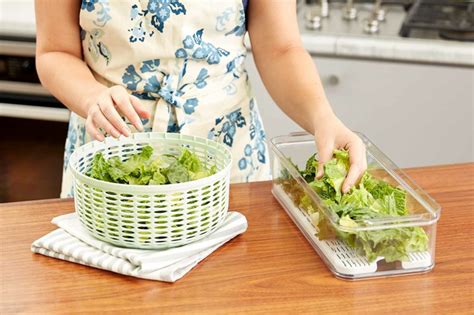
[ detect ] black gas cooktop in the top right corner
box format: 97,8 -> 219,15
400,0 -> 474,42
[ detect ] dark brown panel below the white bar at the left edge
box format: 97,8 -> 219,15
0,117 -> 67,203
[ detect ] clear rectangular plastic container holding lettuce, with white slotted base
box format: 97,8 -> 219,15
271,133 -> 441,280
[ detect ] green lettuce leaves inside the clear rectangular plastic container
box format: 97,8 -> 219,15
284,150 -> 429,262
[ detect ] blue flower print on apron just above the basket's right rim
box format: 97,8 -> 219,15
207,108 -> 246,147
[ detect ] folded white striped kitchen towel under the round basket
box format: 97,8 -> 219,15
31,212 -> 247,282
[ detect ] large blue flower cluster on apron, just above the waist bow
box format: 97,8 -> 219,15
175,29 -> 229,65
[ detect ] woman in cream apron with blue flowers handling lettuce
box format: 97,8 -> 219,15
36,0 -> 366,197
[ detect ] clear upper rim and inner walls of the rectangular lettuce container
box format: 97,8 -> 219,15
270,132 -> 441,232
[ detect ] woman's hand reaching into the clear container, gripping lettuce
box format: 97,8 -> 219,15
314,113 -> 367,193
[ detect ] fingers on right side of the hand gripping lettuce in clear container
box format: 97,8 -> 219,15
342,137 -> 367,193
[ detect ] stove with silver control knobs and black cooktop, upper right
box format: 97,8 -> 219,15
303,0 -> 474,42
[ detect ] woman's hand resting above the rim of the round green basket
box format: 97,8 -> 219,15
84,85 -> 150,141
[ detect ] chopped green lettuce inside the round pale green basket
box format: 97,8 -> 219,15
88,146 -> 217,185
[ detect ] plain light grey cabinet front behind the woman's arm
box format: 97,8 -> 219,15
246,54 -> 474,167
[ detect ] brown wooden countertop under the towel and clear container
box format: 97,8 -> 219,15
0,164 -> 474,314
